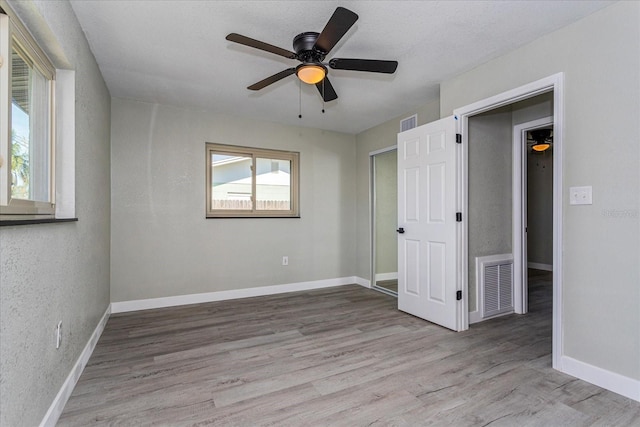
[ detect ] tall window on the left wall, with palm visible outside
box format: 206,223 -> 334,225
0,10 -> 55,219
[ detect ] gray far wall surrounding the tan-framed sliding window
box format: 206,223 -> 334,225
111,99 -> 356,301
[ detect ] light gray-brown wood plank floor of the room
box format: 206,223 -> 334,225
59,275 -> 640,427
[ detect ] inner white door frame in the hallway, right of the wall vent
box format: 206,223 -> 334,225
512,116 -> 553,314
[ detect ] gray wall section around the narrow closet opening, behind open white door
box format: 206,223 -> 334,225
355,100 -> 440,280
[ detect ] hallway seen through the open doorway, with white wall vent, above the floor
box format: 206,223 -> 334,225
467,92 -> 553,323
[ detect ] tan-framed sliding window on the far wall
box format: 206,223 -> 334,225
206,143 -> 300,218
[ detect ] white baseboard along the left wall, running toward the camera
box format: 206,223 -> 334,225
40,306 -> 111,427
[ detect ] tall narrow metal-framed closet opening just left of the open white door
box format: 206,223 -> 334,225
369,146 -> 398,297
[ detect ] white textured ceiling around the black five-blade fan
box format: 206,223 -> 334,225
71,0 -> 610,133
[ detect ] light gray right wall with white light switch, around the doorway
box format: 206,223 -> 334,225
440,2 -> 640,380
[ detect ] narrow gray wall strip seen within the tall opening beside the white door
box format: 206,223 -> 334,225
375,150 -> 398,274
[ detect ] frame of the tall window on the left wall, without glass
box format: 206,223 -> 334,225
0,10 -> 56,221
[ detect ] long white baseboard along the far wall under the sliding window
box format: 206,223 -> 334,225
111,276 -> 360,314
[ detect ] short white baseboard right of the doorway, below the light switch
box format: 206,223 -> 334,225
561,356 -> 640,402
